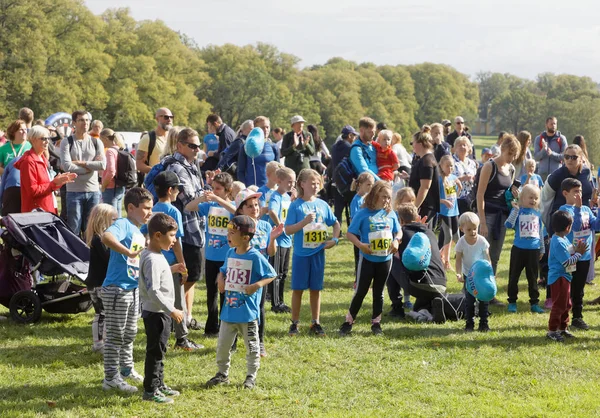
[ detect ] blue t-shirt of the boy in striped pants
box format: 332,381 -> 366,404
102,218 -> 146,290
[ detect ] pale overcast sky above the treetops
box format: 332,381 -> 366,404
85,0 -> 600,82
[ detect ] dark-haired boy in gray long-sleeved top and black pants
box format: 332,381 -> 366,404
139,214 -> 185,403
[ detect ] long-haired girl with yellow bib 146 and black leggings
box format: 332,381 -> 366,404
339,180 -> 402,336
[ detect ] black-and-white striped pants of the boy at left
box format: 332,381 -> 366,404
102,286 -> 140,380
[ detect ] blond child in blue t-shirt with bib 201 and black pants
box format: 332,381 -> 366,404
505,184 -> 545,313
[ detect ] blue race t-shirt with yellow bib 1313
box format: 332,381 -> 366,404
284,198 -> 337,257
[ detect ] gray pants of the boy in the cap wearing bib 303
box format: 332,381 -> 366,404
217,320 -> 260,379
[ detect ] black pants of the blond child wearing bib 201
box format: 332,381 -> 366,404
508,246 -> 540,305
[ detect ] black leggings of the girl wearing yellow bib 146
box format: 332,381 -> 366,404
349,254 -> 392,322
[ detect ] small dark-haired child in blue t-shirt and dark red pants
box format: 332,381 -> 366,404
546,210 -> 589,342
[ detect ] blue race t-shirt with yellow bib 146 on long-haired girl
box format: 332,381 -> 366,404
348,208 -> 400,263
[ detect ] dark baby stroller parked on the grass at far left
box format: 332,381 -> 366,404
0,211 -> 92,324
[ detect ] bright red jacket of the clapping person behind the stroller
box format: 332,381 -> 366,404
15,149 -> 58,213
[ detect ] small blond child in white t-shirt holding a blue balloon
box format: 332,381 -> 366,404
455,212 -> 490,332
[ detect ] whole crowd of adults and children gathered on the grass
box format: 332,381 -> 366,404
0,108 -> 600,403
